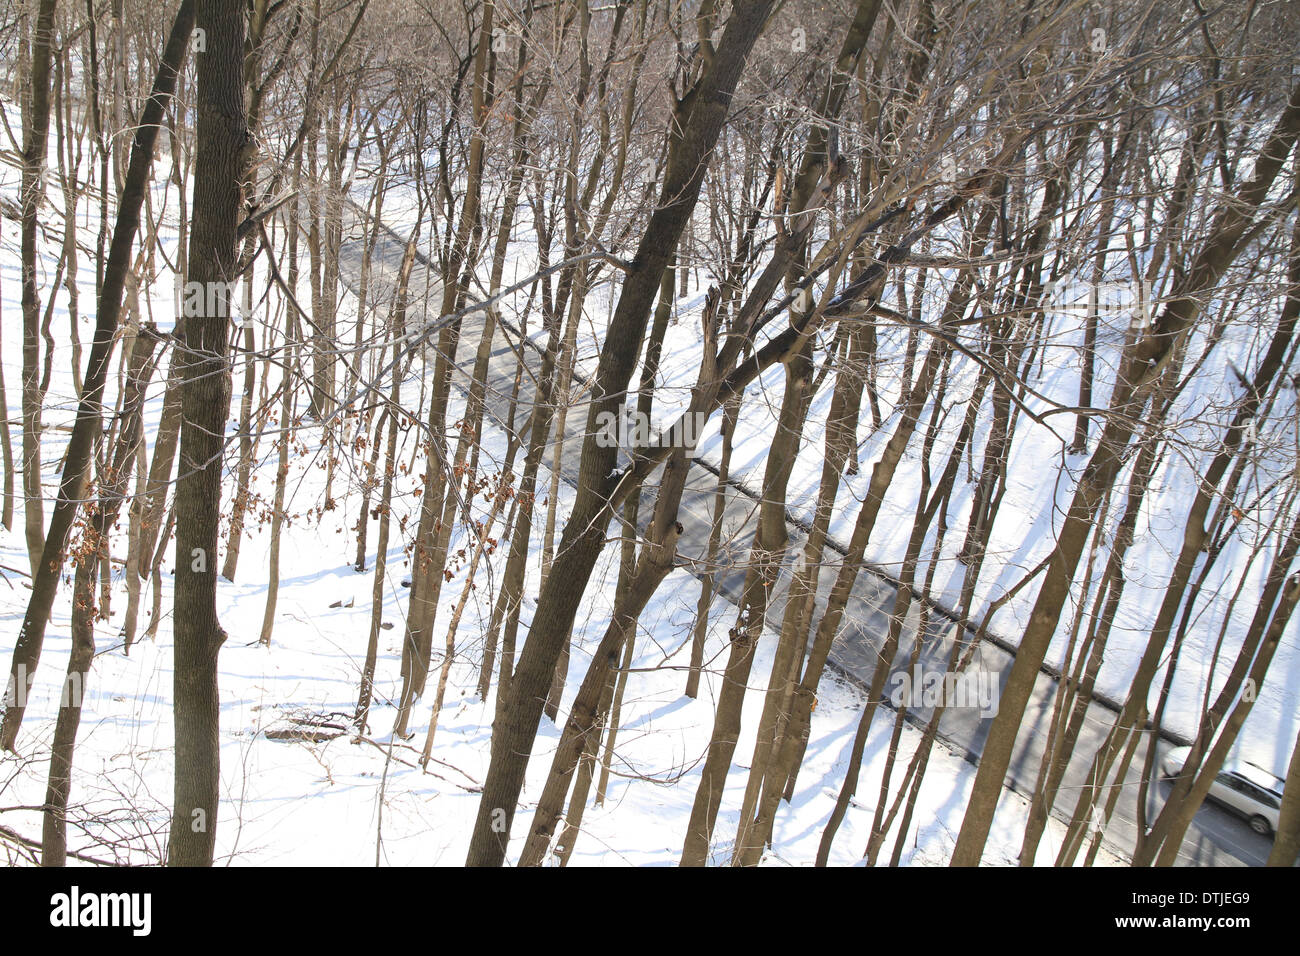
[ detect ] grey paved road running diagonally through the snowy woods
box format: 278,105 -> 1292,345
330,207 -> 1271,866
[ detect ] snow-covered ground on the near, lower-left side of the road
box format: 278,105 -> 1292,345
0,316 -> 1118,865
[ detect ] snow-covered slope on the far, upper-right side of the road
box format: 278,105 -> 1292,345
371,158 -> 1300,777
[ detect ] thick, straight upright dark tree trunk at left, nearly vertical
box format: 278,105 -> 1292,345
168,0 -> 247,866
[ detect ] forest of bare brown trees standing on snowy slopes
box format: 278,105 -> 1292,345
0,0 -> 1300,866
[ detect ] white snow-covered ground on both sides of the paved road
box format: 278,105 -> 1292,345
0,87 -> 1284,865
